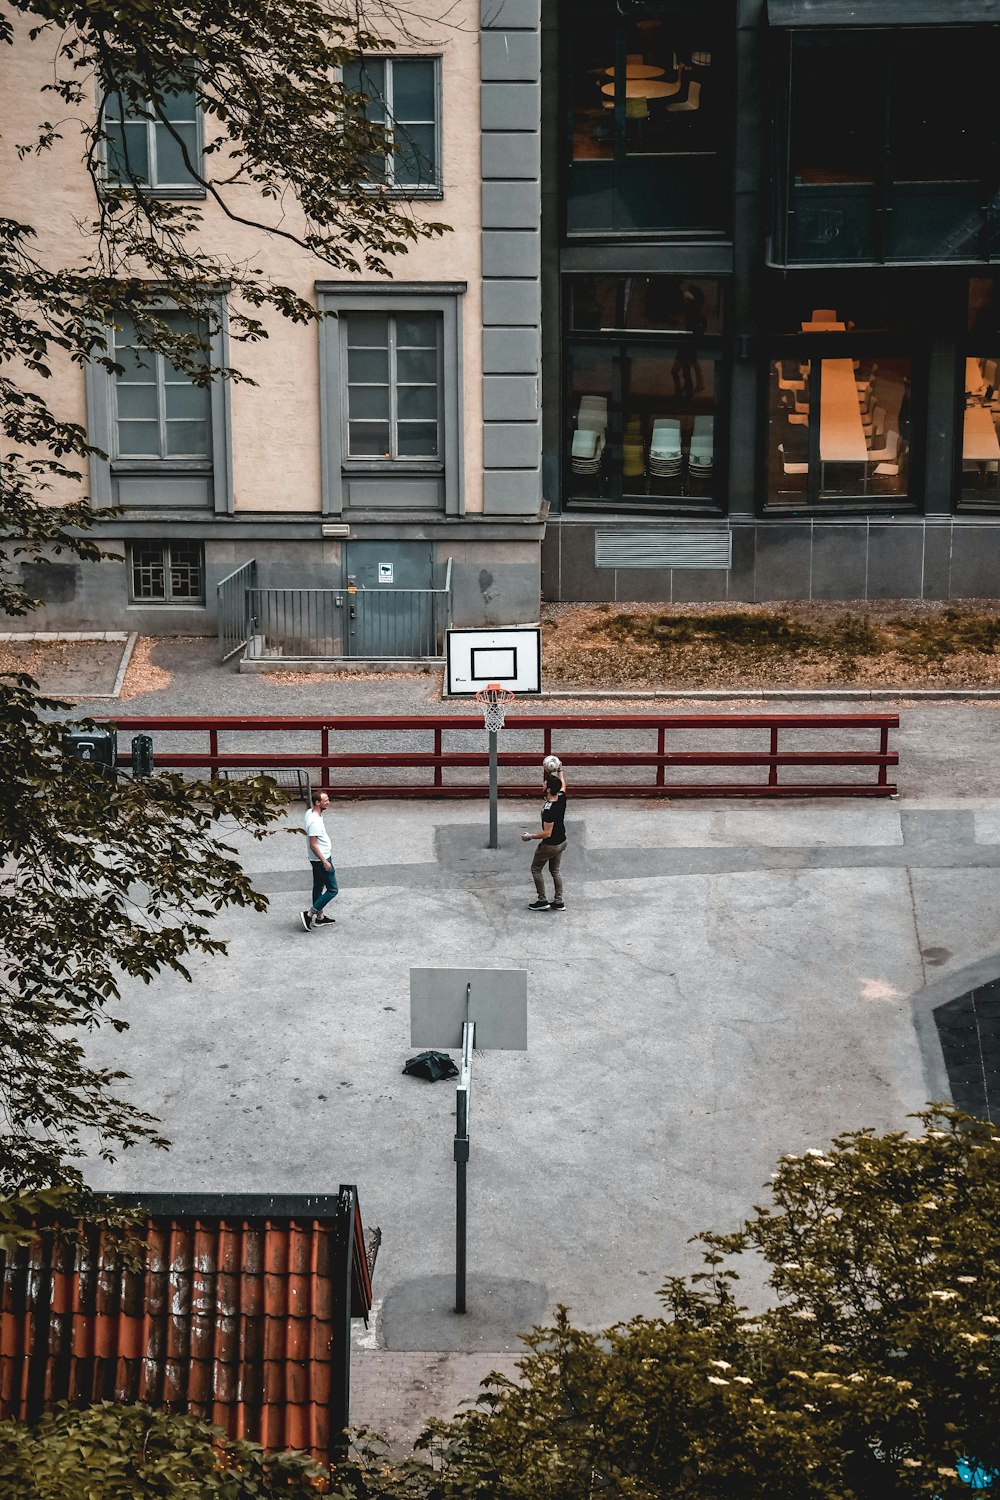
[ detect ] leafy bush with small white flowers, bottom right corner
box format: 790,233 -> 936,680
399,1106 -> 1000,1500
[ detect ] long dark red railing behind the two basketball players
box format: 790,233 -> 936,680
105,714 -> 900,798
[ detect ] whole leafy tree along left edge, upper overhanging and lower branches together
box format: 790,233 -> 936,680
0,0 -> 444,1194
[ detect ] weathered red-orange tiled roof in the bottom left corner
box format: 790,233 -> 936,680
0,1188 -> 373,1460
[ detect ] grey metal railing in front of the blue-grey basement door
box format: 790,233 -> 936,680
246,558 -> 451,662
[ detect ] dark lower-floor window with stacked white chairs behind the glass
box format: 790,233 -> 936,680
562,276 -> 724,515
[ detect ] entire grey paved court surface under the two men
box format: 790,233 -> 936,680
80,774 -> 1000,1449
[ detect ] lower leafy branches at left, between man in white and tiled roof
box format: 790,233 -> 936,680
0,678 -> 282,1194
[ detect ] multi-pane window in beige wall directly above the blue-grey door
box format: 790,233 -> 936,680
342,312 -> 441,461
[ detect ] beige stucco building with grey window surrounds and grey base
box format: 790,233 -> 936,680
0,0 -> 544,654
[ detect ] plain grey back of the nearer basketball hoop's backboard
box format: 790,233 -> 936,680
409,969 -> 528,1052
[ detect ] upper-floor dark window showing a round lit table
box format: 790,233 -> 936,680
561,0 -> 735,234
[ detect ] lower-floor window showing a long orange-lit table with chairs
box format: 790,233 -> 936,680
768,341 -> 912,506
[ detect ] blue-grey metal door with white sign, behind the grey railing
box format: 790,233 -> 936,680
343,542 -> 438,657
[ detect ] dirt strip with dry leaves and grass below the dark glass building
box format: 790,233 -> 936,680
543,600 -> 1000,692
